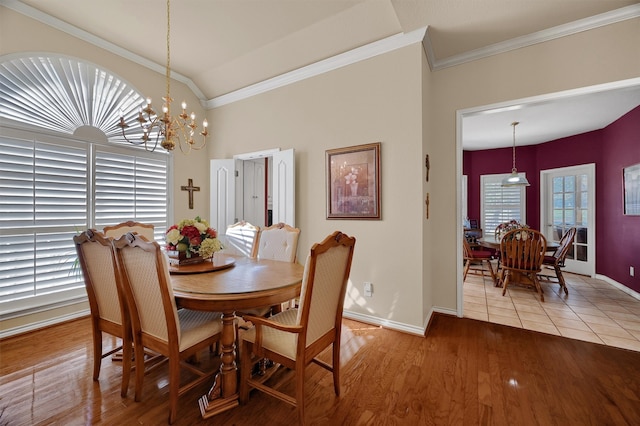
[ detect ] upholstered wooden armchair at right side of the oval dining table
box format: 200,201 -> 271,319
240,231 -> 356,424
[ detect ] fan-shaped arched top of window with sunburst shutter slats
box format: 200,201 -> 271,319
0,55 -> 151,143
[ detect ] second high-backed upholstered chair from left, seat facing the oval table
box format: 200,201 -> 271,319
113,233 -> 222,423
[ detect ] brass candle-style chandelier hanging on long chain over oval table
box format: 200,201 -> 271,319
117,0 -> 209,154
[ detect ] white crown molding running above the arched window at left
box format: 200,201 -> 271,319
0,0 -> 206,102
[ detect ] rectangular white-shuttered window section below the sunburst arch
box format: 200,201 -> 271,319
0,131 -> 169,313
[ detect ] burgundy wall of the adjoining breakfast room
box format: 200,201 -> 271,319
462,107 -> 640,292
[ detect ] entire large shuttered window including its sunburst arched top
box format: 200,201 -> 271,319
0,54 -> 170,326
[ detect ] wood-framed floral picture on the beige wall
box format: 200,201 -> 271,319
326,142 -> 380,220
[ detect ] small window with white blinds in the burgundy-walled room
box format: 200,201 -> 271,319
480,173 -> 526,235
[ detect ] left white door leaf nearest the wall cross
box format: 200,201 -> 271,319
209,160 -> 236,235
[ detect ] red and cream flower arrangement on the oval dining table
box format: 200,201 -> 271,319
166,216 -> 223,259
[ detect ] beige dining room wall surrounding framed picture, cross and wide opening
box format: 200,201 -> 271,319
0,7 -> 640,332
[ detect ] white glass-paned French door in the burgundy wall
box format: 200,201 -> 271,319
540,164 -> 596,276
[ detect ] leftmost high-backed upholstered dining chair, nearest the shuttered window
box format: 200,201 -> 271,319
73,229 -> 133,397
